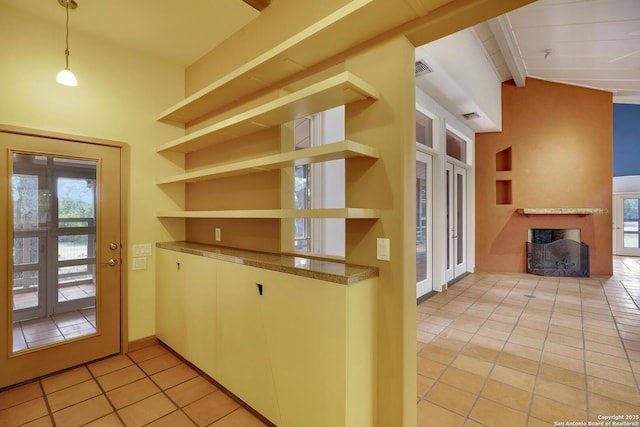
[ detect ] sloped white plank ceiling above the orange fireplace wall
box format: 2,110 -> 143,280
477,0 -> 640,103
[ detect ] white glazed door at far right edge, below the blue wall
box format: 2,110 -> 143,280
613,193 -> 640,256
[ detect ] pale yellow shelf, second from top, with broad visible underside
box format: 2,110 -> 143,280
156,71 -> 379,153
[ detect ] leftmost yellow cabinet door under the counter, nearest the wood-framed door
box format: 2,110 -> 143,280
156,249 -> 217,377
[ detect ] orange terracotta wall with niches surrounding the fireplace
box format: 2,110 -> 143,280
476,79 -> 613,275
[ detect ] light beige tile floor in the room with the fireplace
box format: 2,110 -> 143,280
417,257 -> 640,427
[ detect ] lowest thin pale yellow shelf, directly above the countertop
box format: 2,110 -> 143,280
156,208 -> 380,219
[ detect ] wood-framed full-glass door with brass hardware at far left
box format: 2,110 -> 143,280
0,131 -> 122,388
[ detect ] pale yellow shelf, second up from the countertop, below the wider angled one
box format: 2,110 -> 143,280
156,140 -> 379,184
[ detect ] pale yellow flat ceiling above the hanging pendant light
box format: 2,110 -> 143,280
0,0 -> 259,67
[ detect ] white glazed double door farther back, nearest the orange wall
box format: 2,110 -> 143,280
445,162 -> 467,282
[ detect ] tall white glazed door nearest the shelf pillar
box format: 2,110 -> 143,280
416,151 -> 433,298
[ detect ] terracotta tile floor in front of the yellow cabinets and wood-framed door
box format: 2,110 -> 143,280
0,345 -> 267,427
